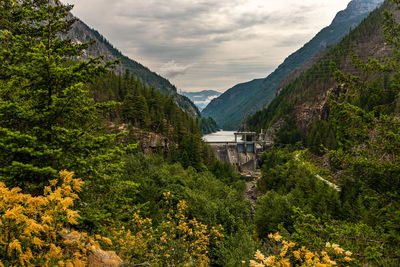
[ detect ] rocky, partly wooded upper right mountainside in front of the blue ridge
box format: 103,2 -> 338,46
246,2 -> 392,136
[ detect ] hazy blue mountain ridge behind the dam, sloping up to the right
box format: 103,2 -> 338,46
202,0 -> 383,129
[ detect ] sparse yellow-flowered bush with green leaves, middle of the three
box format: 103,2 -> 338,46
101,193 -> 223,266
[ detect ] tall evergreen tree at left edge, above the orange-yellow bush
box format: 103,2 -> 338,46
0,0 -> 118,193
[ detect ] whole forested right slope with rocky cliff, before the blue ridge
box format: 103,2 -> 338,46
247,0 -> 400,266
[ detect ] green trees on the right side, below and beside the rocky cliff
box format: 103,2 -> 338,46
255,1 -> 400,266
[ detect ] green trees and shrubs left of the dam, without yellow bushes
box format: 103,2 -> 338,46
0,0 -> 256,266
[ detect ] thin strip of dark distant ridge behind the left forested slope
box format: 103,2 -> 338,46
68,16 -> 200,116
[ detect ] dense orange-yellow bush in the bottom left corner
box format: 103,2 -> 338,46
0,171 -> 87,266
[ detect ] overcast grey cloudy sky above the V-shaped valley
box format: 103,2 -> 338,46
65,0 -> 350,92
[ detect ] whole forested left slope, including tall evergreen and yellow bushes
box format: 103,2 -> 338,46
0,0 -> 255,266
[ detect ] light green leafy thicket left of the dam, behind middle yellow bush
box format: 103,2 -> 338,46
121,154 -> 256,266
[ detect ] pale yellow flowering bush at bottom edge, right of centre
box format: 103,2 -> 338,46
250,232 -> 352,267
